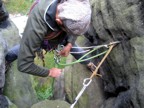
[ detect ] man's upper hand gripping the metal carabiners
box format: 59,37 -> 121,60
59,43 -> 72,57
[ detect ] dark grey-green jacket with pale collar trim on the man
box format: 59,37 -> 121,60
18,0 -> 76,77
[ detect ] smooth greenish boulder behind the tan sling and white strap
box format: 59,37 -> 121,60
64,38 -> 105,108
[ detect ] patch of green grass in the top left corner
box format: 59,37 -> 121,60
4,0 -> 34,14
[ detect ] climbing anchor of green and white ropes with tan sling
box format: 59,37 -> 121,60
55,41 -> 120,108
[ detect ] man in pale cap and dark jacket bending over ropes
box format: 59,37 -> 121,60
5,0 -> 93,77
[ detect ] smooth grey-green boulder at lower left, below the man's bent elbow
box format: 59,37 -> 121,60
5,61 -> 37,108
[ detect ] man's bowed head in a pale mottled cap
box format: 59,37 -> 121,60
56,0 -> 91,35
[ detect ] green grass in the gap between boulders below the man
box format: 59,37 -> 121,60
33,52 -> 66,100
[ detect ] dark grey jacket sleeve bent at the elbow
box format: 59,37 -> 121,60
18,11 -> 49,77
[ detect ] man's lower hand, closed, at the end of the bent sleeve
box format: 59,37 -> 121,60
49,68 -> 62,78
